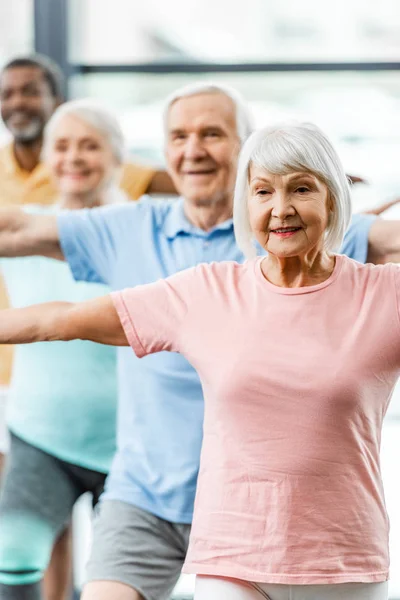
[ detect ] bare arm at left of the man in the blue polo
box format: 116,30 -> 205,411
0,208 -> 64,260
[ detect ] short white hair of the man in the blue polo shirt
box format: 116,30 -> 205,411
163,82 -> 254,144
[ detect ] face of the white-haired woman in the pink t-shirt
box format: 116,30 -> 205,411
248,166 -> 332,258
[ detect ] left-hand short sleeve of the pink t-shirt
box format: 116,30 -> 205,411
111,268 -> 198,358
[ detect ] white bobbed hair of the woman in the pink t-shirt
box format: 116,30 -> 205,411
233,123 -> 352,258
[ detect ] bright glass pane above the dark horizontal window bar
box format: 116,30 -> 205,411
69,0 -> 400,64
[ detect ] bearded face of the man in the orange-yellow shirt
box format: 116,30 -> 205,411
0,67 -> 59,144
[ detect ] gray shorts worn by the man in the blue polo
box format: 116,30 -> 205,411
87,500 -> 190,600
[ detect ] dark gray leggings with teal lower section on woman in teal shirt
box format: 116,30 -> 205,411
0,434 -> 106,600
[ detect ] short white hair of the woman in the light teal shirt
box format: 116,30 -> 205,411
43,99 -> 125,164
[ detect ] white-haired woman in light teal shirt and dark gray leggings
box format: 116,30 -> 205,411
0,101 -> 127,600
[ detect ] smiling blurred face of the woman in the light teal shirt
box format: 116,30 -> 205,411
47,115 -> 117,194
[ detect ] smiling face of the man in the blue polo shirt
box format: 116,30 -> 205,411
166,93 -> 240,206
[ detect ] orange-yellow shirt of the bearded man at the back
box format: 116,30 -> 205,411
0,143 -> 156,385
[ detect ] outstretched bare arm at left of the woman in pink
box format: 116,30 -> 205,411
0,296 -> 129,346
